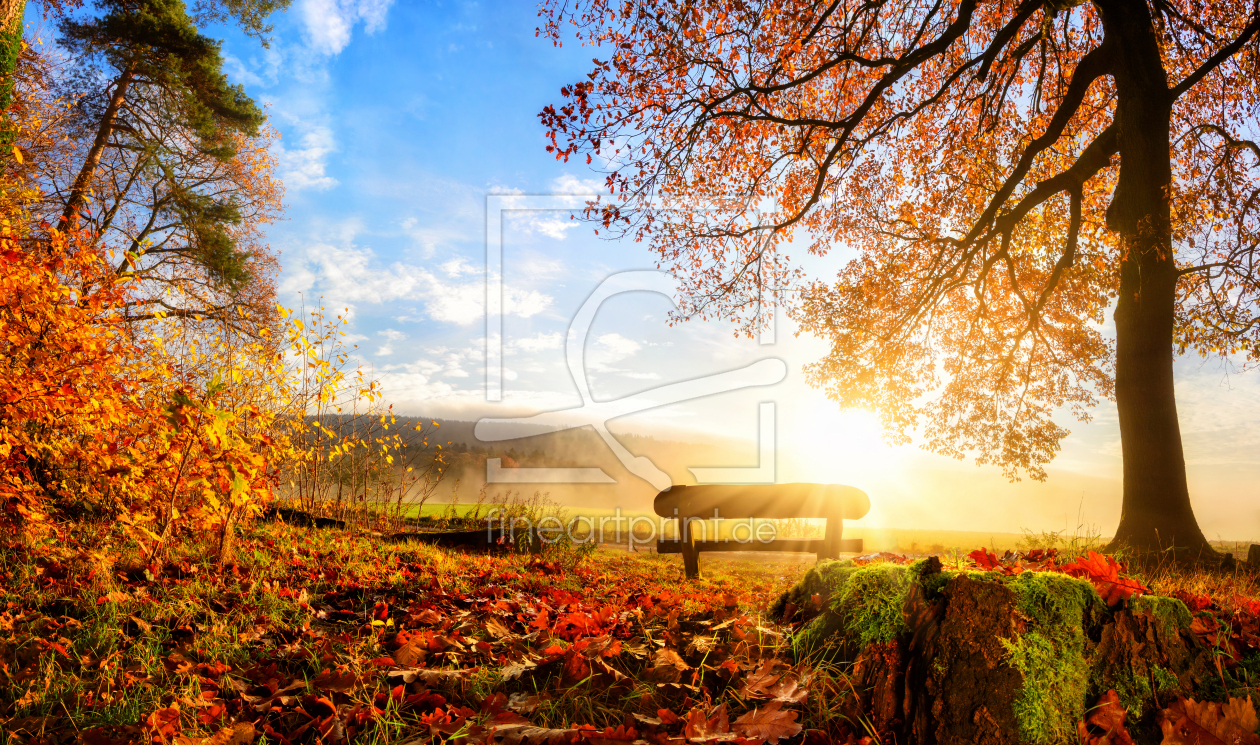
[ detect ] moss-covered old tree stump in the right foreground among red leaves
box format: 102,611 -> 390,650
771,558 -> 1223,745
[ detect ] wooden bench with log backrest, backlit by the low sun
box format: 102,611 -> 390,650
653,484 -> 871,579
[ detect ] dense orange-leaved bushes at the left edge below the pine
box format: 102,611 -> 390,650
0,215 -> 281,553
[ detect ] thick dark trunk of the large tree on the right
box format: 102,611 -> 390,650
1099,0 -> 1211,555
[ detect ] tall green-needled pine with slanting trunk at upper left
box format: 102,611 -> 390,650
43,0 -> 281,328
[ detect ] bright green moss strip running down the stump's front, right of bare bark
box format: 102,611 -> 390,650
1003,572 -> 1101,745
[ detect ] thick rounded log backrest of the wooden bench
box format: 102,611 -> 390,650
653,484 -> 871,519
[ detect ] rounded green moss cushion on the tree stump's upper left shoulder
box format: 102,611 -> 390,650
830,563 -> 916,648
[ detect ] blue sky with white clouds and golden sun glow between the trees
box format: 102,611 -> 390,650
191,0 -> 1260,538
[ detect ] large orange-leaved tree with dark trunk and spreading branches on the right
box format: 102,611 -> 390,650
541,0 -> 1260,552
